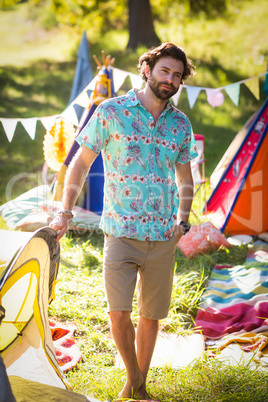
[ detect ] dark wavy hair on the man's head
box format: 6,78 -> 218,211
137,42 -> 195,82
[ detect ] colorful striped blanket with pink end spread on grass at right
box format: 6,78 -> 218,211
196,241 -> 268,339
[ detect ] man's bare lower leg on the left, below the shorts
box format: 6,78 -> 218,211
109,311 -> 144,400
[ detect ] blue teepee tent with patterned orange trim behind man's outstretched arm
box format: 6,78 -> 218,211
53,52 -> 115,215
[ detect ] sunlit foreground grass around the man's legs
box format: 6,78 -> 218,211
49,233 -> 268,402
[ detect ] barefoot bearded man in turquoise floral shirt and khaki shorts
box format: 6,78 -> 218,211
51,43 -> 197,401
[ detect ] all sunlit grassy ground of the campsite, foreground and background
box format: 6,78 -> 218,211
0,0 -> 268,402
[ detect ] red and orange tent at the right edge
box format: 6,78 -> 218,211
207,99 -> 268,235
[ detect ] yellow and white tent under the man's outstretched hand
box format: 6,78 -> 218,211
0,227 -> 101,402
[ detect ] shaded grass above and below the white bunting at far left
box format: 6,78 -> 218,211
0,61 -> 75,204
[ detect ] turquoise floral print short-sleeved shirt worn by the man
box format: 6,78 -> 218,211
77,89 -> 197,241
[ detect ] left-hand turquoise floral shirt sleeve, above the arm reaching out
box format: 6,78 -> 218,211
76,101 -> 110,154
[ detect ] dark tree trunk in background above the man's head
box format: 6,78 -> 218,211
127,0 -> 161,49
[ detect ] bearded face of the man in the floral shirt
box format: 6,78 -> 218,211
147,57 -> 184,100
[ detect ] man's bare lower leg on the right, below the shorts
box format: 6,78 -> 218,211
137,316 -> 159,399
